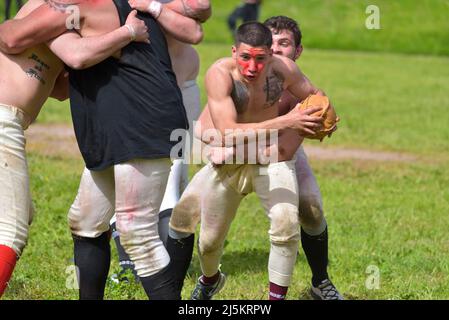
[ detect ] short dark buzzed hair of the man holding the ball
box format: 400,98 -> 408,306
235,21 -> 273,48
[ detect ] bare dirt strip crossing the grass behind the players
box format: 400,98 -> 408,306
25,124 -> 419,162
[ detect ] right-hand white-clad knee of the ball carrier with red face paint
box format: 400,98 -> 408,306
270,204 -> 300,245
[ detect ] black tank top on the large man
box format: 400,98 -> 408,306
70,0 -> 188,170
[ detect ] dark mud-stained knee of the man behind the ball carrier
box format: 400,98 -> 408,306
298,194 -> 324,231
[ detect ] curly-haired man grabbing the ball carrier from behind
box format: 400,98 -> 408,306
192,16 -> 342,300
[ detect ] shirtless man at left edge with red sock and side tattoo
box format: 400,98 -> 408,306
0,0 -> 148,296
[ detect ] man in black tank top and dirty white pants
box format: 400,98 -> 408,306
0,0 -> 207,299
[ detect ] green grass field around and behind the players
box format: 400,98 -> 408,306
0,0 -> 449,300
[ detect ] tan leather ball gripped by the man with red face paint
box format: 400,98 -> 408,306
296,94 -> 340,141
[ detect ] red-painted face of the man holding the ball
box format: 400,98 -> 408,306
237,48 -> 268,80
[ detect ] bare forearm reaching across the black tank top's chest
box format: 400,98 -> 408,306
50,26 -> 132,69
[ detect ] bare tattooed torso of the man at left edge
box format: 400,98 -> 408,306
0,0 -> 63,120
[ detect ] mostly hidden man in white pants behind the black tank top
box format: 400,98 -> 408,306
107,0 -> 210,282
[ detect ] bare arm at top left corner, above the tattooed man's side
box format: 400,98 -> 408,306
0,1 -> 76,54
